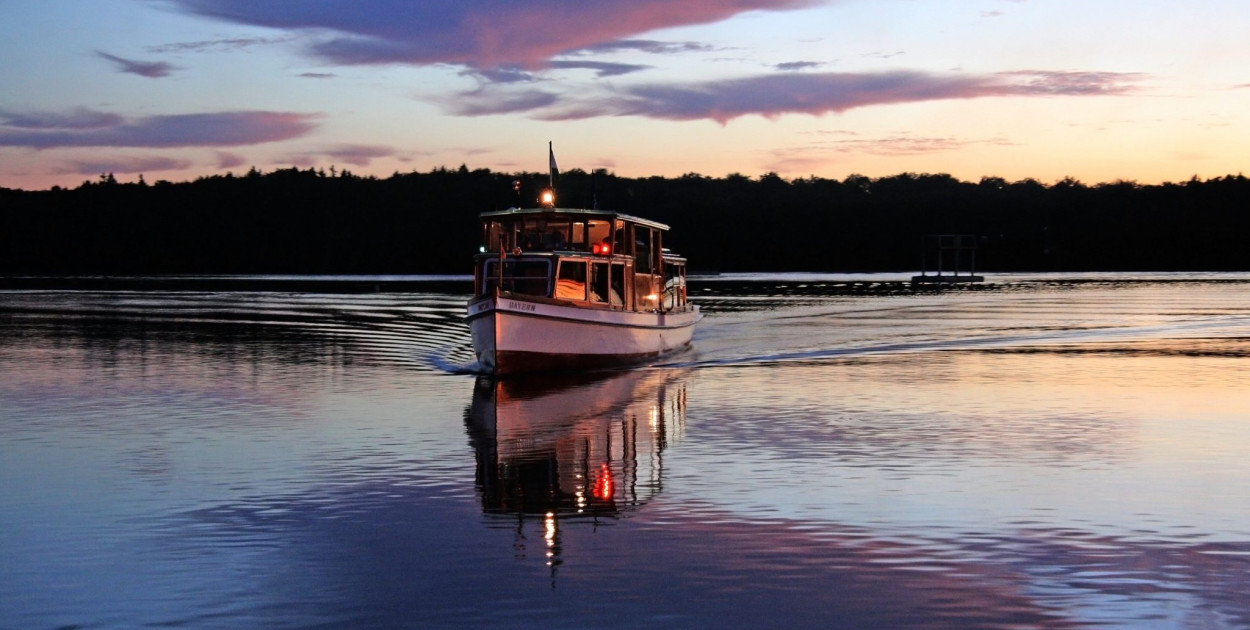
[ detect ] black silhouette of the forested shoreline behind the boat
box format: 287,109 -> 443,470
0,166 -> 1250,274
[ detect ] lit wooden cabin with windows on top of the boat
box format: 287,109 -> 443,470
474,208 -> 690,313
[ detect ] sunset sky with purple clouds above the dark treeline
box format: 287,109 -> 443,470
0,0 -> 1250,189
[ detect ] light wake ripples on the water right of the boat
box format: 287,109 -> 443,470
661,286 -> 1250,368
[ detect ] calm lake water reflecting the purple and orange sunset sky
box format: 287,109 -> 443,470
0,274 -> 1250,629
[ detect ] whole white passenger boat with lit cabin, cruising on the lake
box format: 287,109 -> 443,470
465,189 -> 703,376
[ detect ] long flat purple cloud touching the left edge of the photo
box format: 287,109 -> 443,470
0,111 -> 320,149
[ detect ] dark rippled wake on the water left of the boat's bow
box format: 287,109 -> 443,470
0,291 -> 476,374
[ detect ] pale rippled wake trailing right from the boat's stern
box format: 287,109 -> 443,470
658,295 -> 1250,368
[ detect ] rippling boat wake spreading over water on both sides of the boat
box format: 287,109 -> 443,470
9,281 -> 1250,375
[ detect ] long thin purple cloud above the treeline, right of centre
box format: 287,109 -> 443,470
527,71 -> 1139,124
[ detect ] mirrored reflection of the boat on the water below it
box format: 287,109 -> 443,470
465,370 -> 686,568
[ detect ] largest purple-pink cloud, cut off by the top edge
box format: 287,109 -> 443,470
171,0 -> 829,68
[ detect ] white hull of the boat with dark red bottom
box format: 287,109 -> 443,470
466,295 -> 703,375
